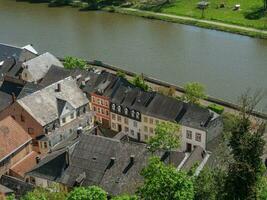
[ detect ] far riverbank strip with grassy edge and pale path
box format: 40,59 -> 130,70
102,7 -> 267,39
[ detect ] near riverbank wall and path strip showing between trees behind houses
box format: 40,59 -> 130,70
78,58 -> 267,120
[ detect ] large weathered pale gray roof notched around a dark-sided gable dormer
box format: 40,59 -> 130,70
17,77 -> 89,126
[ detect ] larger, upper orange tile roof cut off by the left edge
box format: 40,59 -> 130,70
0,116 -> 31,160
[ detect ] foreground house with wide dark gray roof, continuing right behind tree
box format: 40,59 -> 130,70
27,130 -> 209,195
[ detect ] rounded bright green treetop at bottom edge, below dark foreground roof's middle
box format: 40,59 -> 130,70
67,186 -> 107,200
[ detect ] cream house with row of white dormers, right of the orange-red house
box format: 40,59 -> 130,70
110,85 -> 155,141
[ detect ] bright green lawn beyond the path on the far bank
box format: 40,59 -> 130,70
159,0 -> 267,30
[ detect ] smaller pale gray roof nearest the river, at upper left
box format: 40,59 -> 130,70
22,52 -> 64,81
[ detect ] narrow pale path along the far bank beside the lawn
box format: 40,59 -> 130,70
122,8 -> 267,34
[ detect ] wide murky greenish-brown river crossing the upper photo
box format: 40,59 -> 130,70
0,0 -> 267,112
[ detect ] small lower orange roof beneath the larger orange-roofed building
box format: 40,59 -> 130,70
10,151 -> 38,177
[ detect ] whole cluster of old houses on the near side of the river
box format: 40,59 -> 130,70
0,44 -> 222,198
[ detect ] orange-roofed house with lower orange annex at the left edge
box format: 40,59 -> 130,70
0,116 -> 37,179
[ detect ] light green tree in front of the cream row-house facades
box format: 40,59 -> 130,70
148,122 -> 180,152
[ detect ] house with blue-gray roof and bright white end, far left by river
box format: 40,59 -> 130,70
0,43 -> 38,62
